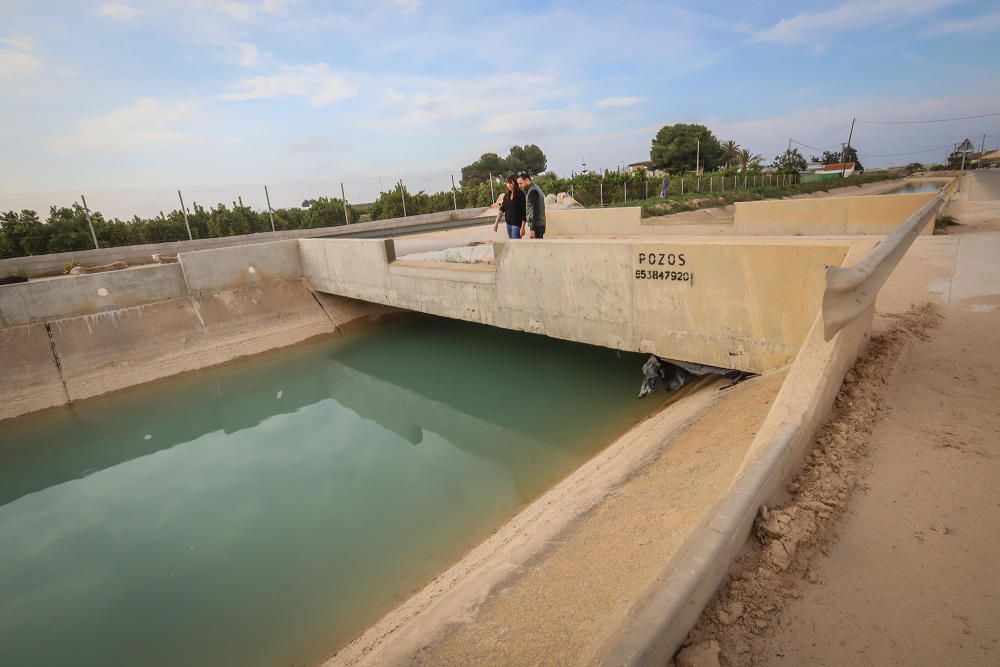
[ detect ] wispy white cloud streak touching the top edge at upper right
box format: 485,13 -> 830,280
750,0 -> 955,44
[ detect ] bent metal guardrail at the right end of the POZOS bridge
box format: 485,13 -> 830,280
822,192 -> 945,341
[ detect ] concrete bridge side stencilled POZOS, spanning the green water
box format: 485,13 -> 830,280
299,238 -> 850,373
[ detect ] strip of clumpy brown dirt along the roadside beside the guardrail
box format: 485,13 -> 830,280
685,304 -> 941,665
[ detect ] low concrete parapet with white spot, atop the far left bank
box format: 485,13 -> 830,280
0,264 -> 187,327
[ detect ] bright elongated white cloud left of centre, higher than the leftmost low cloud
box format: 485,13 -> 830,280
220,63 -> 359,106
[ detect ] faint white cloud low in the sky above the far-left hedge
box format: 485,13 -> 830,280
50,97 -> 198,154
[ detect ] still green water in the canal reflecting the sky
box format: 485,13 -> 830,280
0,318 -> 653,667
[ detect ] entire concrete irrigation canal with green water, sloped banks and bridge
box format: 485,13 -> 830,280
0,178 -> 976,665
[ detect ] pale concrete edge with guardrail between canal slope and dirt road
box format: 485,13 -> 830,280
601,193 -> 946,665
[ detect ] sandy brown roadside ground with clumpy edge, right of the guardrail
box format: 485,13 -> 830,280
678,174 -> 1000,666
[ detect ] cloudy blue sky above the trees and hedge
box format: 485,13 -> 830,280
0,0 -> 1000,215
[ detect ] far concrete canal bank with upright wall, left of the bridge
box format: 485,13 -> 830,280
0,240 -> 398,419
